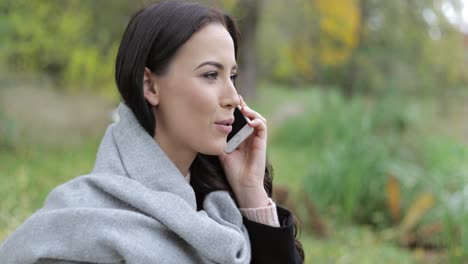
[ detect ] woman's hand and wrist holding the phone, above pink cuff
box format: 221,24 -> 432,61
219,97 -> 269,208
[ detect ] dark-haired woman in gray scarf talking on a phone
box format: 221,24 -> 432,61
0,2 -> 303,264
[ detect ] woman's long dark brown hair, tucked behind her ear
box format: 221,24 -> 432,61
115,1 -> 304,258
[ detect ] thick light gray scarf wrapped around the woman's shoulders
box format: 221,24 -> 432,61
0,104 -> 251,264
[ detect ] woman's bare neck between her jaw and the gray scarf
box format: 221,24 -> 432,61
154,133 -> 197,177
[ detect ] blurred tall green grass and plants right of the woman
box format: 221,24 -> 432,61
252,84 -> 468,263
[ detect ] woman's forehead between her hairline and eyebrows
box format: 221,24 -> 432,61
169,23 -> 236,67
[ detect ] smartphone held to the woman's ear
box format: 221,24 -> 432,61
224,106 -> 254,153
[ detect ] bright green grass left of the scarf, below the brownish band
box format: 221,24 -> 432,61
0,139 -> 98,241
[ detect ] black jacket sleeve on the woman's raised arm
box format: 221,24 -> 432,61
244,205 -> 302,264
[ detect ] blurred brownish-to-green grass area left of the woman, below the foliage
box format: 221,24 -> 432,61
0,84 -> 112,240
